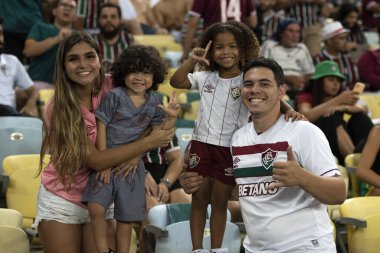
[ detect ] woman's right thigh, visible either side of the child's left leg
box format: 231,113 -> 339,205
82,220 -> 116,253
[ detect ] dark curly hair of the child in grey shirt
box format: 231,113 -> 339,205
111,45 -> 168,91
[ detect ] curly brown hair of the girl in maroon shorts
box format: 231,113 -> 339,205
197,21 -> 260,71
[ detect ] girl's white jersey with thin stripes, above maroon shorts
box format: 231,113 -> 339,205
188,71 -> 249,147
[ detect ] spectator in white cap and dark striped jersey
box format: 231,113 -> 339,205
314,21 -> 359,88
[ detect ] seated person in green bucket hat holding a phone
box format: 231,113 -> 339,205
297,61 -> 373,164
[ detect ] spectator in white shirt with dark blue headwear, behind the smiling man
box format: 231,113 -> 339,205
261,19 -> 314,99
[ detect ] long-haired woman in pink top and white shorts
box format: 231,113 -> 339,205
35,32 -> 174,253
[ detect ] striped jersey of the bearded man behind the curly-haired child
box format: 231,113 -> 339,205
94,31 -> 135,73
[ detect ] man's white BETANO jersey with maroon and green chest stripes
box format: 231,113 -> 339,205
231,116 -> 340,252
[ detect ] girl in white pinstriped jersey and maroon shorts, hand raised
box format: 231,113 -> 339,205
170,21 -> 298,252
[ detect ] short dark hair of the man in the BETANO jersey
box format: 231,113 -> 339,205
243,56 -> 285,86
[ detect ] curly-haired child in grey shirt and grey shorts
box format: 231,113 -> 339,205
83,45 -> 180,253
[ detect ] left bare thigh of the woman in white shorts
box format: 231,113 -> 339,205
38,220 -> 82,253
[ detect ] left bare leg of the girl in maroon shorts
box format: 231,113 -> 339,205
190,177 -> 211,250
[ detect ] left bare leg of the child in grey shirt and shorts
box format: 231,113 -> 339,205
88,202 -> 109,253
